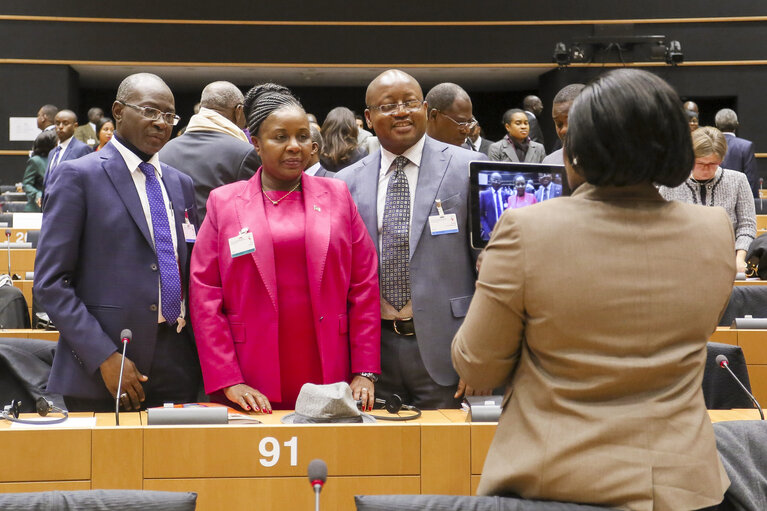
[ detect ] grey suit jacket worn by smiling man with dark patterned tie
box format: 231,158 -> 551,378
336,137 -> 485,386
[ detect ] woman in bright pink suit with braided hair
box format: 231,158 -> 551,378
190,84 -> 381,413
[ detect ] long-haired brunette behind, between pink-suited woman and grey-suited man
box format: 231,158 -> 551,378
320,106 -> 368,172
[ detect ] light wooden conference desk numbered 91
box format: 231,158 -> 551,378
0,410 -> 758,511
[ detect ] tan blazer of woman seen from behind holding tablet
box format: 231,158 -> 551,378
452,184 -> 735,511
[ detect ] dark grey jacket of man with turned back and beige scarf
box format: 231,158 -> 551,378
160,131 -> 261,222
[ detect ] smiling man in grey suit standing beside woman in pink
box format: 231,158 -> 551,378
336,70 -> 484,408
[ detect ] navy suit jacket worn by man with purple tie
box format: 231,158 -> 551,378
34,144 -> 197,399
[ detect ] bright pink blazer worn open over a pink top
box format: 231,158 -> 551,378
190,170 -> 381,401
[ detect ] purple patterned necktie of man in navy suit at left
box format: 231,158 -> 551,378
138,162 -> 181,325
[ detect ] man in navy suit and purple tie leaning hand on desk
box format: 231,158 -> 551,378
34,73 -> 200,411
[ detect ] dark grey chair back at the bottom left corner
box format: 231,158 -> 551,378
0,490 -> 197,511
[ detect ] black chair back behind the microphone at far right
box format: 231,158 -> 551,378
703,342 -> 754,410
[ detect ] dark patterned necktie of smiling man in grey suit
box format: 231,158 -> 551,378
381,156 -> 410,310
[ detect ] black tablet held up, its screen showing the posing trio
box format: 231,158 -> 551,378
469,161 -> 570,249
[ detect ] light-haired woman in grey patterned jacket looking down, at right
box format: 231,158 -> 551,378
660,126 -> 756,272
